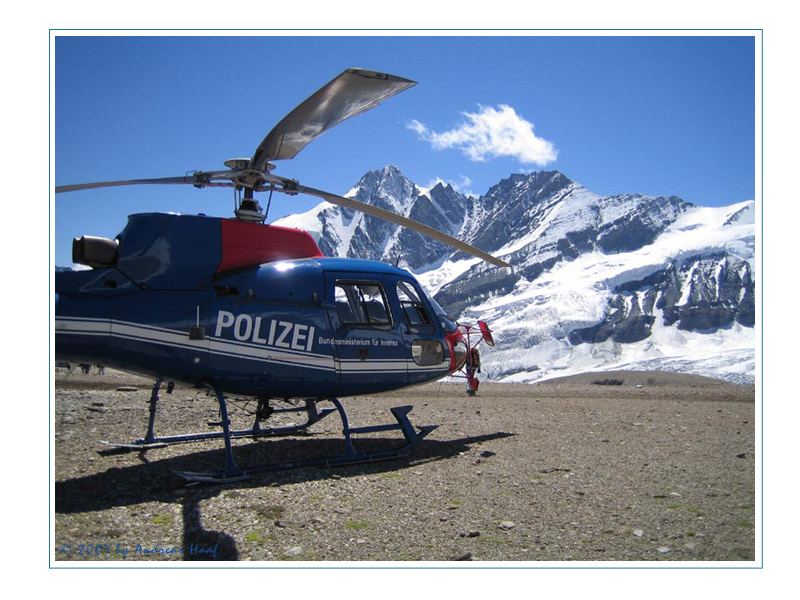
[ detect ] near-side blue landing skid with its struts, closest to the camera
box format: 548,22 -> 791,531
177,388 -> 436,482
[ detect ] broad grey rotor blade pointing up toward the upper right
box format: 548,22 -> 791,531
250,69 -> 417,171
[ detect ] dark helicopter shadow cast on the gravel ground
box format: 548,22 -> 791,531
55,432 -> 514,561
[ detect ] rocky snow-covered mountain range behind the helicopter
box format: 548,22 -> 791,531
276,165 -> 755,383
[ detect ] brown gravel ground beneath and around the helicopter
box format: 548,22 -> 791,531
53,371 -> 756,561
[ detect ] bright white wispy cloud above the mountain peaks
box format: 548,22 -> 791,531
407,104 -> 558,166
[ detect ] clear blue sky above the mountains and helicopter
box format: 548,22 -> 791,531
52,32 -> 760,265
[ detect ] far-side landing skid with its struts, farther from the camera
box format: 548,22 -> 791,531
101,380 -> 336,450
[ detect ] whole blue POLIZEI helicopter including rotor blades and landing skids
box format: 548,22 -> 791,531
55,68 -> 509,482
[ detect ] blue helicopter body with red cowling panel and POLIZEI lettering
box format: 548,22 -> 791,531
55,213 -> 461,398
